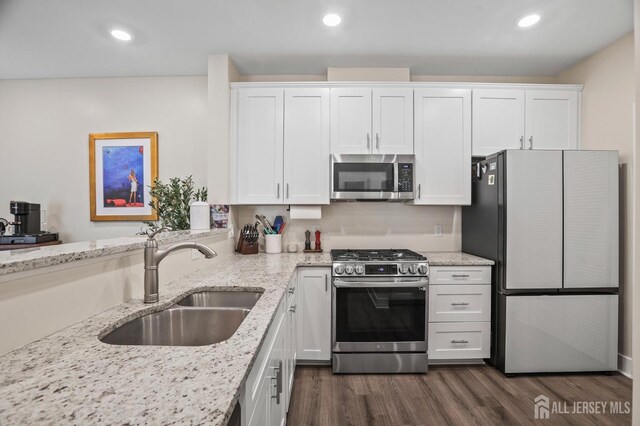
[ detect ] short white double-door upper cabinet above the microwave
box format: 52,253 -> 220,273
331,88 -> 413,154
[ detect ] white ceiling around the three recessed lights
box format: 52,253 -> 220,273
0,0 -> 633,79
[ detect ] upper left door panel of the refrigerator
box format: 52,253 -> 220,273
504,150 -> 563,290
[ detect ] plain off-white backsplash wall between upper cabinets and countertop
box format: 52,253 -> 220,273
239,202 -> 462,251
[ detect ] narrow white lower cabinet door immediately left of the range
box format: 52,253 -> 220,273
298,268 -> 331,361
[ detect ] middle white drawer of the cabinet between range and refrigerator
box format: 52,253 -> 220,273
429,284 -> 491,322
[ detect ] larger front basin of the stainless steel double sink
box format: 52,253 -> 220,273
100,308 -> 249,346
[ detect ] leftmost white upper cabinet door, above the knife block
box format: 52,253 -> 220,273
237,89 -> 284,204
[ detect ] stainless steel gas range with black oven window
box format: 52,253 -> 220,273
331,250 -> 429,373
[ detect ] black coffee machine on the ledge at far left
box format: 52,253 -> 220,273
0,201 -> 58,245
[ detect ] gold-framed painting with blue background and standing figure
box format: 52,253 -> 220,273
89,132 -> 158,221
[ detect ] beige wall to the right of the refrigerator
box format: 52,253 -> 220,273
557,33 -> 635,366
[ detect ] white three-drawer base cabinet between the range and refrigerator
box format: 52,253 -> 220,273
428,266 -> 491,363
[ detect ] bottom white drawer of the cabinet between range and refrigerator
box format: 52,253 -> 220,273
429,322 -> 491,359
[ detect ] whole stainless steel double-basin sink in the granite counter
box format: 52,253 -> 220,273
100,290 -> 262,346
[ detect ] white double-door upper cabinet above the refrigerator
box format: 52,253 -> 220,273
473,89 -> 580,156
